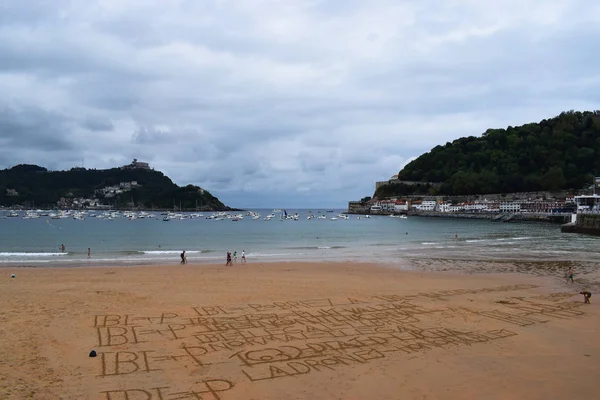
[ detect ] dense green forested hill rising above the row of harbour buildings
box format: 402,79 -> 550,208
375,111 -> 600,197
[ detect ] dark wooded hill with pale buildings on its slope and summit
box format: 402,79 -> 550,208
0,164 -> 230,211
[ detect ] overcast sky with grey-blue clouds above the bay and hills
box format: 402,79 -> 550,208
0,0 -> 600,208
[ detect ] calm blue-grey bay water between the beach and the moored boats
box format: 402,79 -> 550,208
0,210 -> 600,266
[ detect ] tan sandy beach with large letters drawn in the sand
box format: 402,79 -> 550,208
0,262 -> 600,400
